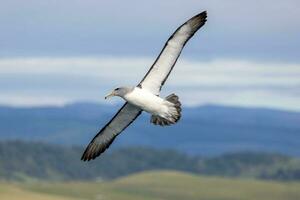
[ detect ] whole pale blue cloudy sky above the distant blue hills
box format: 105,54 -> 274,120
0,0 -> 300,111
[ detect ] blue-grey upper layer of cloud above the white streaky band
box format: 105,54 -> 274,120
0,0 -> 300,62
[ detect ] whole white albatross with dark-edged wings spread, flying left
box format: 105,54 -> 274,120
81,11 -> 207,161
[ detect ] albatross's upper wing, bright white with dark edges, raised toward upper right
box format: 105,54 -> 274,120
139,11 -> 207,95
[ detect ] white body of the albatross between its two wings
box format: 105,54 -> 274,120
124,87 -> 172,117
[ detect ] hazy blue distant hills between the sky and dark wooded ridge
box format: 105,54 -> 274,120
0,103 -> 300,156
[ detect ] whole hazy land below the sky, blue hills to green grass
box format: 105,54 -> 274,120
0,103 -> 300,200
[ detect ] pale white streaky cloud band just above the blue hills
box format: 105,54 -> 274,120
0,57 -> 300,111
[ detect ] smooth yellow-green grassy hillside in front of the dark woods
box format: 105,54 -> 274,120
0,171 -> 300,200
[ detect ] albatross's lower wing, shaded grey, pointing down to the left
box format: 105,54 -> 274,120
81,103 -> 142,161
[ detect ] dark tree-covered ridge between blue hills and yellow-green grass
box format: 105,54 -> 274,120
0,141 -> 300,181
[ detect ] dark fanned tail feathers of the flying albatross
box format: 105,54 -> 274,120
151,94 -> 181,126
